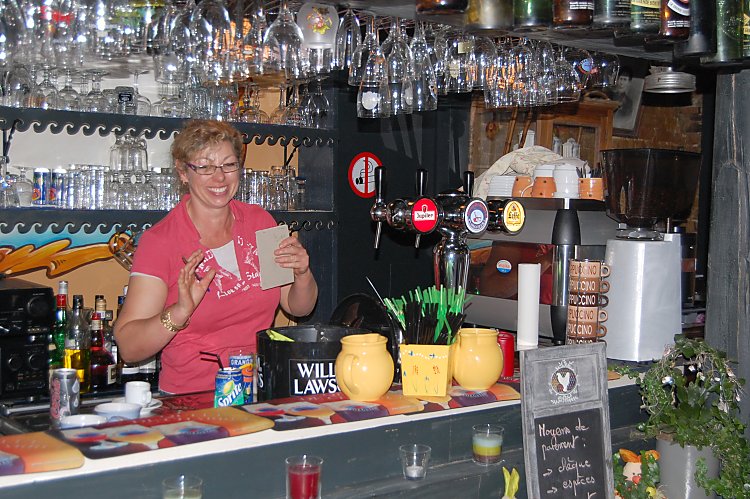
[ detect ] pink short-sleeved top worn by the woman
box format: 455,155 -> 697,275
132,195 -> 281,393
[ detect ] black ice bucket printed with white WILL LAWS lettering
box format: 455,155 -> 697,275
256,324 -> 371,402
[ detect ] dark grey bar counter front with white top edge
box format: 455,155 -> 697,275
0,378 -> 648,499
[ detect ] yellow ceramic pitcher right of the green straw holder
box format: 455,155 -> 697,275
453,327 -> 503,390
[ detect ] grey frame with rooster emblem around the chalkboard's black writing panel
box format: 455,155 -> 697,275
520,343 -> 615,499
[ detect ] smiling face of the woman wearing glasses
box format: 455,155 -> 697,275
178,140 -> 241,209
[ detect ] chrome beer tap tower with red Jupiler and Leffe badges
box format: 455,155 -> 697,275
370,166 -> 526,289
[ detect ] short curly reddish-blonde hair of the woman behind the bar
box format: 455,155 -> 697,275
172,120 -> 242,163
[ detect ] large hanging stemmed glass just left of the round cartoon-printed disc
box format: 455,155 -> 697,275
262,0 -> 306,80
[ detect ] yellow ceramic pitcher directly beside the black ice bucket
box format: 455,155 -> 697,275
336,333 -> 393,402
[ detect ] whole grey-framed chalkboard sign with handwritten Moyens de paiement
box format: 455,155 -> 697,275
521,343 -> 614,499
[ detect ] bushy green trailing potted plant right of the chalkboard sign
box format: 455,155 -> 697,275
617,335 -> 750,499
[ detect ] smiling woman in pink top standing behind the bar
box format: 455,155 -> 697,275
115,120 -> 318,393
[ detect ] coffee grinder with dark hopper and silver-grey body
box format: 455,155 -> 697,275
602,149 -> 700,361
